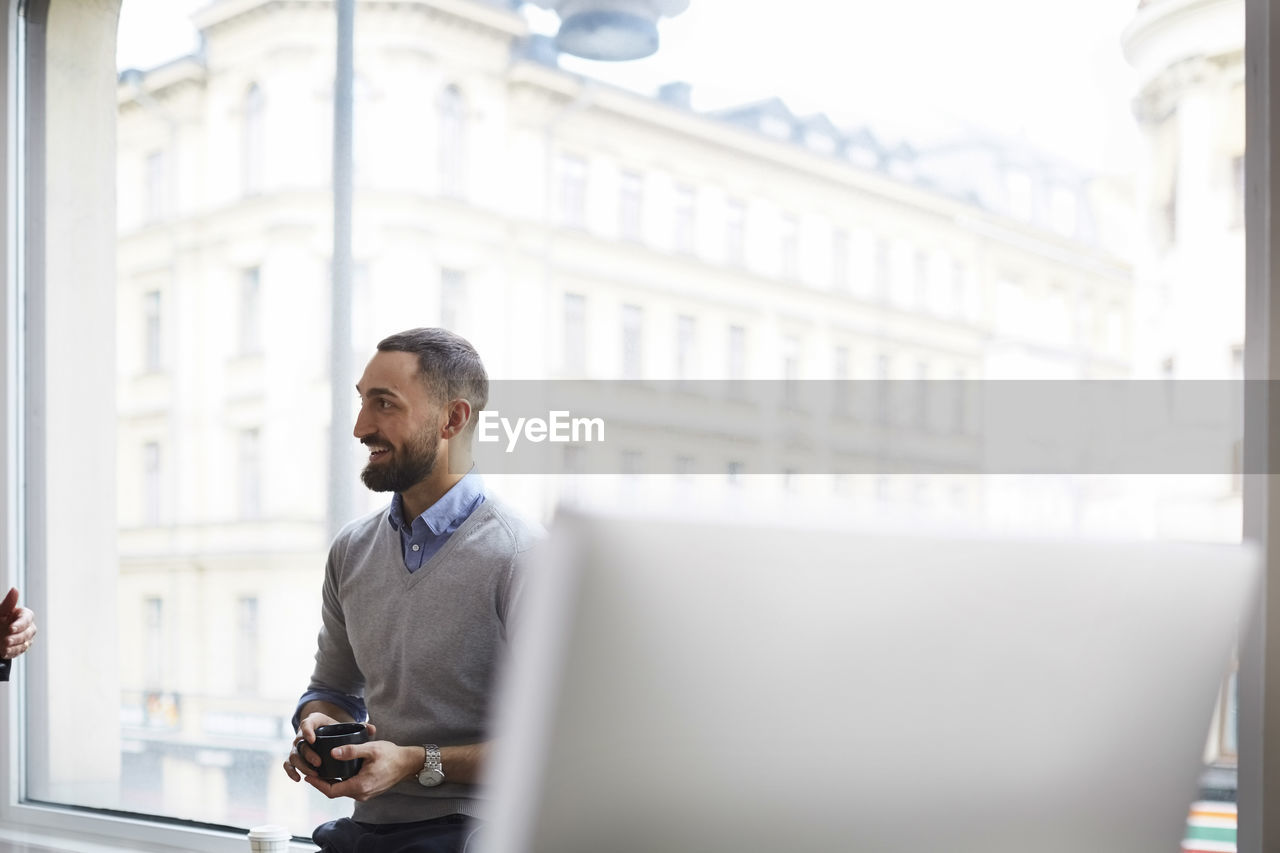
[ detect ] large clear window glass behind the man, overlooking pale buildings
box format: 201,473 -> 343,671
29,0 -> 1244,834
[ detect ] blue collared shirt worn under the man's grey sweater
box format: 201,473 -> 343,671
293,467 -> 484,731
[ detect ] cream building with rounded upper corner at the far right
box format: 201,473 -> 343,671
1123,0 -> 1245,835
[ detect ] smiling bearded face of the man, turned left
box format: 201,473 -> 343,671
355,352 -> 443,492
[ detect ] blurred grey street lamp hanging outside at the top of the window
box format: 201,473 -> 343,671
534,0 -> 689,61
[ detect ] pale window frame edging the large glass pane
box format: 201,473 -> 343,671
0,0 -> 1280,853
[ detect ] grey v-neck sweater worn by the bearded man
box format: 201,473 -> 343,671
308,497 -> 541,824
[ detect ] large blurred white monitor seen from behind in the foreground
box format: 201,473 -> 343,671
477,517 -> 1257,853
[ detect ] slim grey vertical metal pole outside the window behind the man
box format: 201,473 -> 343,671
328,0 -> 356,537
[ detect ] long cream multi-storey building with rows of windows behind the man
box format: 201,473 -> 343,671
107,0 -> 1134,827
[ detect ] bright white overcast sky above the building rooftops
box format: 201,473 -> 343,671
118,0 -> 1138,172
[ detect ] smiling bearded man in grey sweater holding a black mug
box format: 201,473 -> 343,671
284,329 -> 538,853
